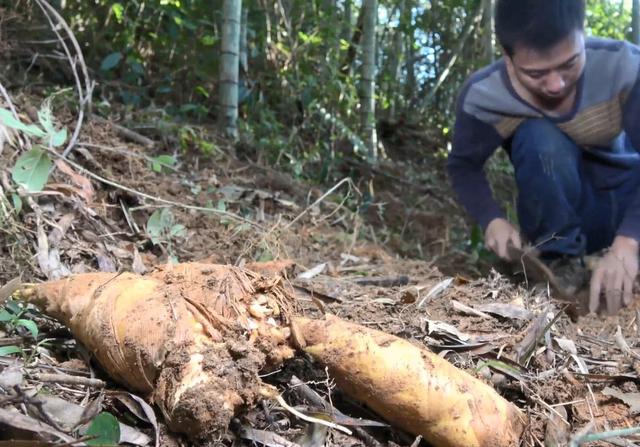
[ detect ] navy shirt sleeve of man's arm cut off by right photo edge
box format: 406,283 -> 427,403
618,77 -> 640,241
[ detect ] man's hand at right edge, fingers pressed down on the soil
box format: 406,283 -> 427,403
589,236 -> 638,315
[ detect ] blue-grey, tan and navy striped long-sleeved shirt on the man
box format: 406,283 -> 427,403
447,37 -> 640,240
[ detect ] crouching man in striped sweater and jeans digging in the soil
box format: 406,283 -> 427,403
448,0 -> 640,313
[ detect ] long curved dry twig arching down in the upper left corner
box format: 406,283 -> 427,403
36,0 -> 94,159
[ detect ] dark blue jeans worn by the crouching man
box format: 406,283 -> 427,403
510,119 -> 640,258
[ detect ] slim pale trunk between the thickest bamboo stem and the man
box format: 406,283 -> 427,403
360,0 -> 378,163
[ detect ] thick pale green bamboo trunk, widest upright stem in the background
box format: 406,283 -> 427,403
220,0 -> 242,139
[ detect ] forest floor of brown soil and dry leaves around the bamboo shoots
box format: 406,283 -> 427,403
0,99 -> 640,447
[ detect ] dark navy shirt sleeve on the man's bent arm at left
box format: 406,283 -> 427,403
447,105 -> 504,229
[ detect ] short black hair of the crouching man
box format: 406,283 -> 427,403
496,0 -> 585,56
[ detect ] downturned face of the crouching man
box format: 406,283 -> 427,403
505,31 -> 585,109
